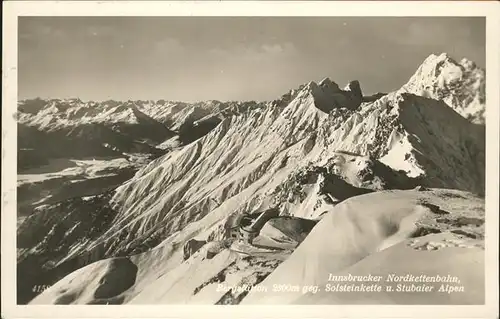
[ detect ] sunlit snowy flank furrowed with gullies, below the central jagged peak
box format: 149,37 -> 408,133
96,84 -> 484,258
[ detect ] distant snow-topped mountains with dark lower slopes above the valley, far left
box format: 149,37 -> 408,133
17,100 -> 174,152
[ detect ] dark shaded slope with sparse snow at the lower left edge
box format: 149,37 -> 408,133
17,191 -> 120,303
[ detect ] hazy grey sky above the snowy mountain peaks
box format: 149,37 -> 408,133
18,17 -> 485,101
